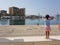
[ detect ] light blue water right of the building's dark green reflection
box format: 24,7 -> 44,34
25,19 -> 58,25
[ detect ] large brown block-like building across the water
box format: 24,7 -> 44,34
9,7 -> 25,19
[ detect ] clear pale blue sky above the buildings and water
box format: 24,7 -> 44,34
0,0 -> 60,16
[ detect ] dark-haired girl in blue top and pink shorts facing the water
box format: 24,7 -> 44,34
45,15 -> 52,39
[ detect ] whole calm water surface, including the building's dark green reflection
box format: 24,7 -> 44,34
0,18 -> 59,25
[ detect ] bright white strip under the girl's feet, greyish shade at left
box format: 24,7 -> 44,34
0,36 -> 60,43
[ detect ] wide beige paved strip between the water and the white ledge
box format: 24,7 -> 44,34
0,25 -> 60,37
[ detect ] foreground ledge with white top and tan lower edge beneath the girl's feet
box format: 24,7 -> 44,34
0,36 -> 60,45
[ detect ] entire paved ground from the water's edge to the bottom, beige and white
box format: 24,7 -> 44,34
0,25 -> 60,45
